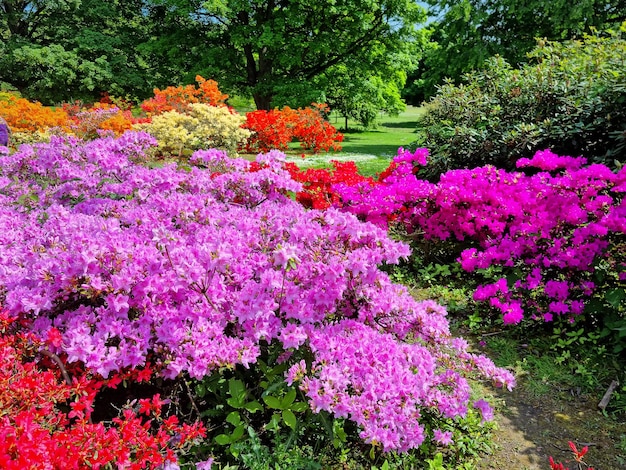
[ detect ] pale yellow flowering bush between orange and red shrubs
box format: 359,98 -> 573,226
136,103 -> 250,156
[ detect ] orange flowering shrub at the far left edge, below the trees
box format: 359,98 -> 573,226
0,94 -> 69,132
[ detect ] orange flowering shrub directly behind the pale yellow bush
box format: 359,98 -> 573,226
141,75 -> 228,116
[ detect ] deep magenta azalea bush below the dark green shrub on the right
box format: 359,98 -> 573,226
334,149 -> 626,323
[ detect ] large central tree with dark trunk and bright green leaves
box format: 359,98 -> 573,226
156,0 -> 425,109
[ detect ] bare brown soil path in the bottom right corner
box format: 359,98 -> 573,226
477,382 -> 626,470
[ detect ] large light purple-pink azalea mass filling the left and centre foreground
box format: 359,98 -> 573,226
0,132 -> 514,451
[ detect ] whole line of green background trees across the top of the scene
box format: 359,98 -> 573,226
0,0 -> 626,123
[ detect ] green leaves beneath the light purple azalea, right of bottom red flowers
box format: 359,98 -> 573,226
179,344 -> 495,470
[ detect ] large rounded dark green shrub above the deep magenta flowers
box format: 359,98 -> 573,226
416,23 -> 626,176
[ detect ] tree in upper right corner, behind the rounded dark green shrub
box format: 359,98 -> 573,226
407,0 -> 626,101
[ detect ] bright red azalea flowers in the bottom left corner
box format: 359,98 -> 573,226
0,311 -> 205,470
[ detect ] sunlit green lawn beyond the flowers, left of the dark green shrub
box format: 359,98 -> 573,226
290,106 -> 423,175
